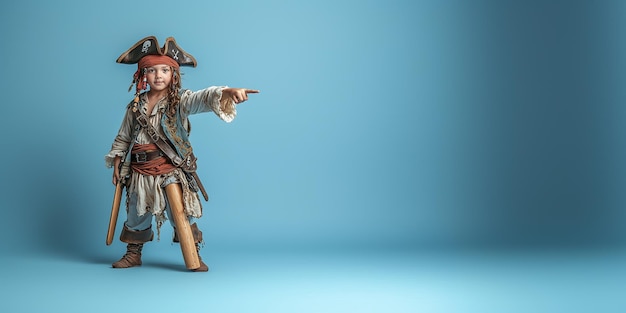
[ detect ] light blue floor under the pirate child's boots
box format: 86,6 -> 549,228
0,243 -> 626,313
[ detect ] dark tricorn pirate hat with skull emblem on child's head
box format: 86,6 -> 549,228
116,36 -> 198,67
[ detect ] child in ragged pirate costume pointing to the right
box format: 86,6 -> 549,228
105,36 -> 259,272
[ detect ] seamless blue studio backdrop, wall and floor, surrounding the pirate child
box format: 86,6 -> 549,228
0,0 -> 626,312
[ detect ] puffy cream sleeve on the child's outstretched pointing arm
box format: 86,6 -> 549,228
180,86 -> 237,123
